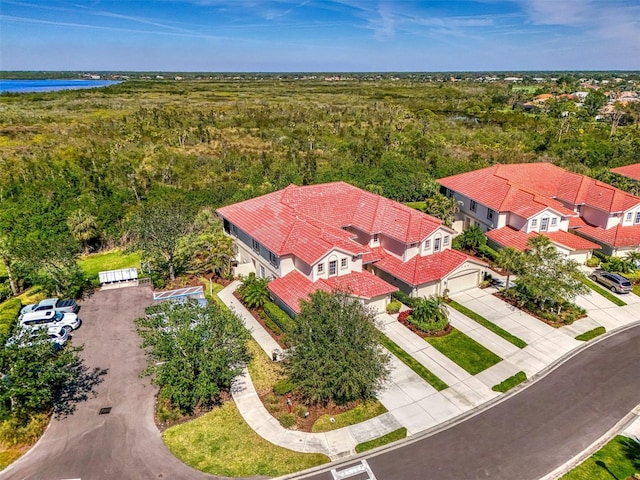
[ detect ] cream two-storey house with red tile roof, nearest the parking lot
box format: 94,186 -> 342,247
217,182 -> 485,313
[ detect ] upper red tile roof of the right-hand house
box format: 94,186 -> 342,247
438,163 -> 640,218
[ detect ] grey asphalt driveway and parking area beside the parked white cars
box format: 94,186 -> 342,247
0,287 -> 224,480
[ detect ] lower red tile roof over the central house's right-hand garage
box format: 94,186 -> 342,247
374,248 -> 486,286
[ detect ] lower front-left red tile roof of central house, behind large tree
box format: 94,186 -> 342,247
268,270 -> 398,313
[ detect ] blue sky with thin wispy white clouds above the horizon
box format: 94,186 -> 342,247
0,0 -> 640,72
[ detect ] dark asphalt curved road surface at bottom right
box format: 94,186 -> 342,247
299,326 -> 640,480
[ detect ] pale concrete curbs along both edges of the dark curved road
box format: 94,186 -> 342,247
272,320 -> 640,480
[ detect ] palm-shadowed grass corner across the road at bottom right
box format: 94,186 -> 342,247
560,435 -> 640,480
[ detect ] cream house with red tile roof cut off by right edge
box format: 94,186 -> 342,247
438,163 -> 640,262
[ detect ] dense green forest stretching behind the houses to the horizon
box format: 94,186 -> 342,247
0,75 -> 640,290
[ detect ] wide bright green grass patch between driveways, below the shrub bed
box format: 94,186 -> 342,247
425,328 -> 502,375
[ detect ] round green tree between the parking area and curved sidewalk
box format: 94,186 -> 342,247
136,302 -> 249,414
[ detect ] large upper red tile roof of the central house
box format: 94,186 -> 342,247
217,182 -> 453,264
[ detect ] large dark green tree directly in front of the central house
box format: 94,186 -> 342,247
284,291 -> 390,405
